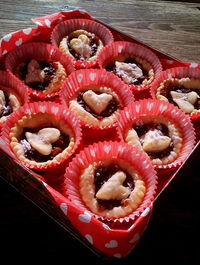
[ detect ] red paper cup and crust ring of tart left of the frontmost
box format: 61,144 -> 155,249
2,102 -> 82,171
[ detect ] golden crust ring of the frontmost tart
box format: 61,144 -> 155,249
80,159 -> 146,218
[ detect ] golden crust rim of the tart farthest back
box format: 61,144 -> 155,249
59,29 -> 104,62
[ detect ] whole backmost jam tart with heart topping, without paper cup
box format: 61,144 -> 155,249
59,29 -> 103,62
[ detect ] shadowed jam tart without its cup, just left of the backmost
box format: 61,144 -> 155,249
15,59 -> 67,94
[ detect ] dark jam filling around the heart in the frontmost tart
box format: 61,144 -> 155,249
94,164 -> 135,210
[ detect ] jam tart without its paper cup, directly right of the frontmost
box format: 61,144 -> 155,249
124,116 -> 182,165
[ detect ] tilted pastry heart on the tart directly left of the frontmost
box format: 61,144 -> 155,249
25,128 -> 60,155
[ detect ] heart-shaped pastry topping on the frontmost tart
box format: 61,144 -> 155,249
96,171 -> 131,200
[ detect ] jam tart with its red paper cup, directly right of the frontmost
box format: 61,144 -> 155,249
117,99 -> 195,169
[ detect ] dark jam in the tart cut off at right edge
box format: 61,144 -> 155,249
160,84 -> 200,110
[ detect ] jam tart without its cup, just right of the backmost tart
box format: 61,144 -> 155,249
106,56 -> 155,85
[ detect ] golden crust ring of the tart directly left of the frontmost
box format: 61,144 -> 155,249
9,113 -> 75,166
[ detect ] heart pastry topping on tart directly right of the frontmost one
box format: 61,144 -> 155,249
142,129 -> 171,152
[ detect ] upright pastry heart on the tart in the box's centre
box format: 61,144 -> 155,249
83,90 -> 112,114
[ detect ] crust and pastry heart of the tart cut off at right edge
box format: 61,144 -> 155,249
156,77 -> 200,114
